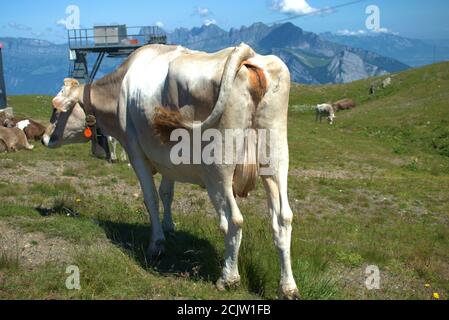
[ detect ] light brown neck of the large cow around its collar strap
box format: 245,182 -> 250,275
80,84 -> 120,138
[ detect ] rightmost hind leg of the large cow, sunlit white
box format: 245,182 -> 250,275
262,143 -> 299,299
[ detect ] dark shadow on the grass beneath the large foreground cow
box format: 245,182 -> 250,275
100,221 -> 220,281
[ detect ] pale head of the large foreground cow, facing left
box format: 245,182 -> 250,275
42,79 -> 89,148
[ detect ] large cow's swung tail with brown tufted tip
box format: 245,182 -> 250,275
153,43 -> 255,141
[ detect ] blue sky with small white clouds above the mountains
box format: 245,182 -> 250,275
0,0 -> 449,42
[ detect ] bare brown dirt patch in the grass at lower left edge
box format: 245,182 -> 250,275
0,221 -> 74,269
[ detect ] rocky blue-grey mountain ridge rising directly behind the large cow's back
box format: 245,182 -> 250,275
168,23 -> 409,84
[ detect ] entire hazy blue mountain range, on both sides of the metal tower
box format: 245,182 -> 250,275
0,23 -> 409,95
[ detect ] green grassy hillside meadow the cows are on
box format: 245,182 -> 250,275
0,63 -> 449,299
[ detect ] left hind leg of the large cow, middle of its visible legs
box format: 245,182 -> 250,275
208,183 -> 243,290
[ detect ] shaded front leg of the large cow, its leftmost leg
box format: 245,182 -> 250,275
129,147 -> 165,258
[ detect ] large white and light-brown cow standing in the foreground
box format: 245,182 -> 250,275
42,44 -> 298,299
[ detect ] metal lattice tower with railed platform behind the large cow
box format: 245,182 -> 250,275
67,25 -> 167,160
